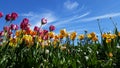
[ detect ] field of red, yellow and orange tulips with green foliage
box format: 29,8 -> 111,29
0,12 -> 120,68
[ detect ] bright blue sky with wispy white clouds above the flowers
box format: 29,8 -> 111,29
0,0 -> 120,35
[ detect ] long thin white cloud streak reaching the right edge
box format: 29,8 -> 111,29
79,12 -> 120,22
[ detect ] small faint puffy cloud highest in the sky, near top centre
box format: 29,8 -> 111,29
64,0 -> 79,10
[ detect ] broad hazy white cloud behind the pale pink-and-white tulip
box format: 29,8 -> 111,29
21,12 -> 57,28
